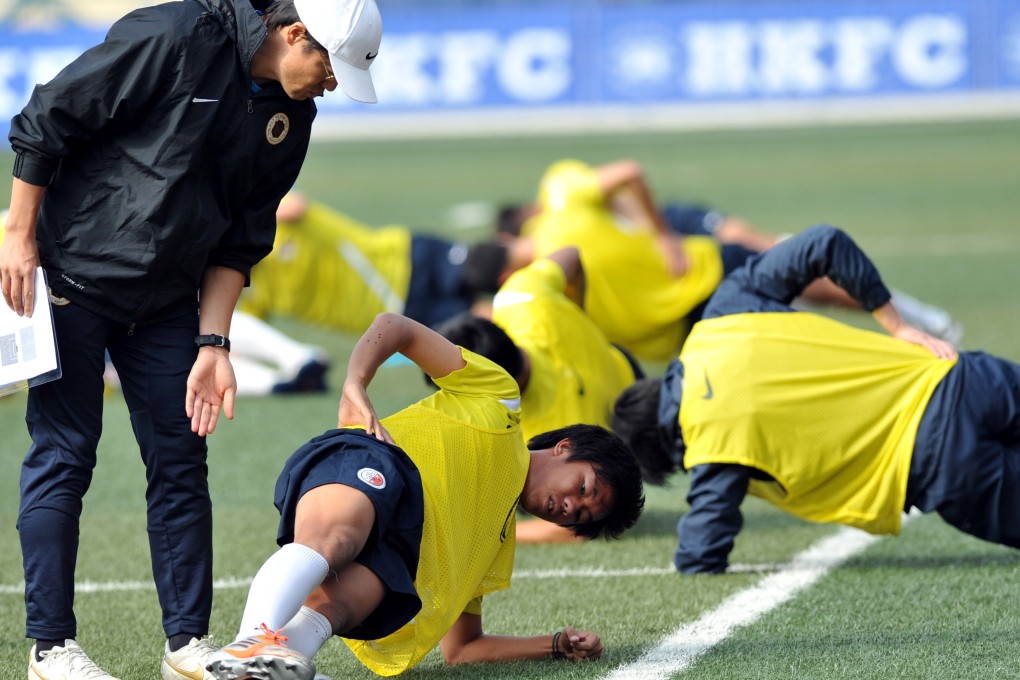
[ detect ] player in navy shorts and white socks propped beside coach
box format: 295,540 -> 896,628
209,313 -> 644,679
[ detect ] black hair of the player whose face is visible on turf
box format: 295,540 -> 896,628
527,425 -> 645,538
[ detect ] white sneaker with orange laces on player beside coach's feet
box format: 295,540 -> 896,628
206,625 -> 315,680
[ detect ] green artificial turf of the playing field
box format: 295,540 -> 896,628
0,120 -> 1020,680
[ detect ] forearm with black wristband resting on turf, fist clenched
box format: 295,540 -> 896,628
440,612 -> 602,664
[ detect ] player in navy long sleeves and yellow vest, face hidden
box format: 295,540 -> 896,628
613,227 -> 1020,573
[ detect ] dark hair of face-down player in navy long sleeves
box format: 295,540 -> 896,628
612,378 -> 677,486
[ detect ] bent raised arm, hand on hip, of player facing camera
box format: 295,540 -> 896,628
338,312 -> 467,443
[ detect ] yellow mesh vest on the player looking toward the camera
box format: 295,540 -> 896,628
344,351 -> 529,676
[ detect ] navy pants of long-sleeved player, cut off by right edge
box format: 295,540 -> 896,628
907,352 -> 1020,547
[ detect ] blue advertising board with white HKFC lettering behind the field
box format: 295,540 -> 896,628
0,0 -> 1020,134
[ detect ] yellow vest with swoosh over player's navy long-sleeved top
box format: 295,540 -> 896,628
680,313 -> 956,533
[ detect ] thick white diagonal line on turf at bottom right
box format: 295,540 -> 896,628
606,517 -> 893,680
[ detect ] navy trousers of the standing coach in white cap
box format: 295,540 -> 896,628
17,303 -> 212,640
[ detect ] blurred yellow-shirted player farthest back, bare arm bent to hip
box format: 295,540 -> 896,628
503,160 -> 959,362
